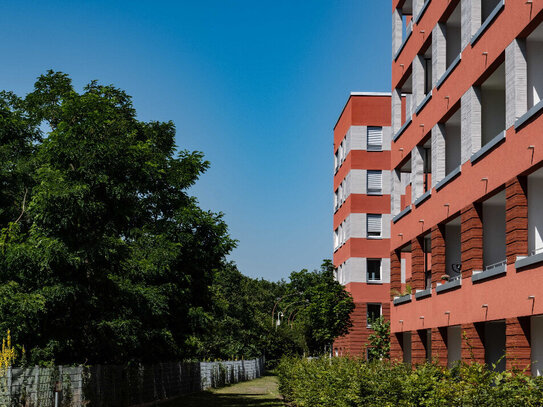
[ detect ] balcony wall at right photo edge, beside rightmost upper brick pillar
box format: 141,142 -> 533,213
528,169 -> 543,255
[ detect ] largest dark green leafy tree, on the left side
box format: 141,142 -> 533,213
0,71 -> 235,363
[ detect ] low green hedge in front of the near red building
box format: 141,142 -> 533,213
277,358 -> 543,407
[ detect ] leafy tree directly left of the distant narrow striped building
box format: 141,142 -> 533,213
289,260 -> 354,354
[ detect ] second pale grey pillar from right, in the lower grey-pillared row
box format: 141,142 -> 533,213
460,86 -> 482,164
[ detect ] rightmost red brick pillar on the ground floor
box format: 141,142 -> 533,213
505,317 -> 532,374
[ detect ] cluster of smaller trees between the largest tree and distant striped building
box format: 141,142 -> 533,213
198,260 -> 354,364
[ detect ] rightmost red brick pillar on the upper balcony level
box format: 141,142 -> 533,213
505,176 -> 528,264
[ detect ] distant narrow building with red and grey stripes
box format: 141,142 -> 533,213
333,93 -> 392,355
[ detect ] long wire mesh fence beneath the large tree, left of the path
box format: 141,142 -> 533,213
0,358 -> 264,407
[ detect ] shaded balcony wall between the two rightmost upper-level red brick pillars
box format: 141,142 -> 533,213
483,196 -> 506,267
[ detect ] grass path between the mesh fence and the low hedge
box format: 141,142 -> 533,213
163,376 -> 285,407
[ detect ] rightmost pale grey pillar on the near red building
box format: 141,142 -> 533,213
505,38 -> 528,129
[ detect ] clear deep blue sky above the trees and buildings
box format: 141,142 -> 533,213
0,0 -> 392,280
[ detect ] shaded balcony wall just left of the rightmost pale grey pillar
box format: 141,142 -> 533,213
481,88 -> 505,147
